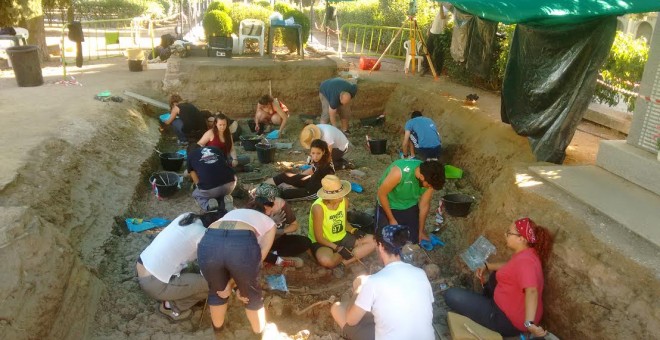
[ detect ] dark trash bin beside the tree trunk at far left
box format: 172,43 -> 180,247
7,45 -> 44,87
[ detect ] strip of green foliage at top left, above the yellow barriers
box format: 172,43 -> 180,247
73,0 -> 147,20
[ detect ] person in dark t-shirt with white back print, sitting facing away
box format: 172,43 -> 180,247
187,144 -> 237,211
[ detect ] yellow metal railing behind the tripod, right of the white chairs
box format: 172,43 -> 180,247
340,24 -> 410,59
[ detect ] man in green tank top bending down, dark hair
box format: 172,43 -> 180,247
376,159 -> 445,243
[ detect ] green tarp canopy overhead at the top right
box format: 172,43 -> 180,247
442,0 -> 660,25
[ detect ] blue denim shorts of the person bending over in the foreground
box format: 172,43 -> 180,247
197,229 -> 264,310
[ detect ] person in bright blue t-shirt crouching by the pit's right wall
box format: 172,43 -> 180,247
401,111 -> 442,161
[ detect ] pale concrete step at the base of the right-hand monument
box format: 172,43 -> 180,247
529,165 -> 660,247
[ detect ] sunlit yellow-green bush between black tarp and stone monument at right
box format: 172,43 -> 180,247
594,32 -> 649,112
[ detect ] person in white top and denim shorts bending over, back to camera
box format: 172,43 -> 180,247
197,207 -> 277,339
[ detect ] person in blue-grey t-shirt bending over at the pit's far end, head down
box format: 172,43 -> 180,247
319,77 -> 357,133
